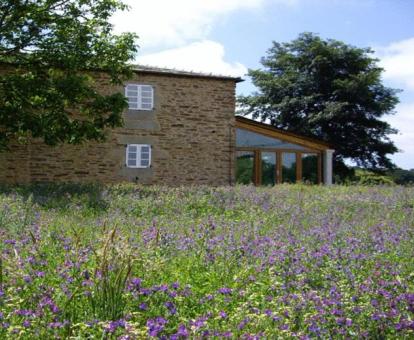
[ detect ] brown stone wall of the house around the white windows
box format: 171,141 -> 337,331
0,73 -> 235,186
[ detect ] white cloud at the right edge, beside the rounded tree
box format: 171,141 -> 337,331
377,38 -> 414,90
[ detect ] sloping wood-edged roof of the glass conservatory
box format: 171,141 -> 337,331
236,116 -> 332,150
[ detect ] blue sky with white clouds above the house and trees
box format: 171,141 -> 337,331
112,0 -> 414,169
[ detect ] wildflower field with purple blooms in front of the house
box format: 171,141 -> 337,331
0,185 -> 414,339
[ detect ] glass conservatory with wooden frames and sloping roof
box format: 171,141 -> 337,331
236,117 -> 334,185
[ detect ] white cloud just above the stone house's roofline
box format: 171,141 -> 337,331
136,40 -> 247,76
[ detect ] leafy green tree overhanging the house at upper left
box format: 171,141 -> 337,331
0,0 -> 137,149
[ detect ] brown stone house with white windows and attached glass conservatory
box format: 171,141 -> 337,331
0,66 -> 332,186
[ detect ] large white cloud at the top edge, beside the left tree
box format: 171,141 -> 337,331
112,0 -> 298,49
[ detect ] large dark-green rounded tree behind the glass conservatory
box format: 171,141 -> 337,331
238,33 -> 398,177
